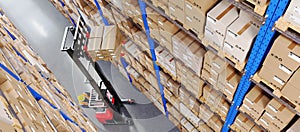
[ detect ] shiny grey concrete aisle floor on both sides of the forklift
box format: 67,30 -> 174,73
0,0 -> 178,132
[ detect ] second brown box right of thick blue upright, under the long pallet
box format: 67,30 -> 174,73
265,98 -> 296,125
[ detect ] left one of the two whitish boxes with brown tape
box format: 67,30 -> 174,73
204,1 -> 238,48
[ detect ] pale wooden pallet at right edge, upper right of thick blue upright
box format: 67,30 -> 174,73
275,17 -> 300,35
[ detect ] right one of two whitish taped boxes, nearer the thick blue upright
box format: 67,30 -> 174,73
223,11 -> 259,63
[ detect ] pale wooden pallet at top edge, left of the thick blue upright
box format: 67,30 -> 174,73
243,0 -> 270,16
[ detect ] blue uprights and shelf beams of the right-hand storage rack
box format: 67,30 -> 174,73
58,0 -> 299,132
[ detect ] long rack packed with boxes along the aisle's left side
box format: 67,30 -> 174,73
0,8 -> 97,131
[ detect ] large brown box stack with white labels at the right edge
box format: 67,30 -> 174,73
258,36 -> 300,105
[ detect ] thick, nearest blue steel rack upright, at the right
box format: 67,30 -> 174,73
222,0 -> 289,132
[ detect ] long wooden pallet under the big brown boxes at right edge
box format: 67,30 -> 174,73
252,73 -> 300,113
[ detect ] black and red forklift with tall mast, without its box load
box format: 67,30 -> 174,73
61,16 -> 135,125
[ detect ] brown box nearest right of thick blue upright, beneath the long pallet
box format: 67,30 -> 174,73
241,86 -> 270,119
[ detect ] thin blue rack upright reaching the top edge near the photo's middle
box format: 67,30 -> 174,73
138,0 -> 169,118
